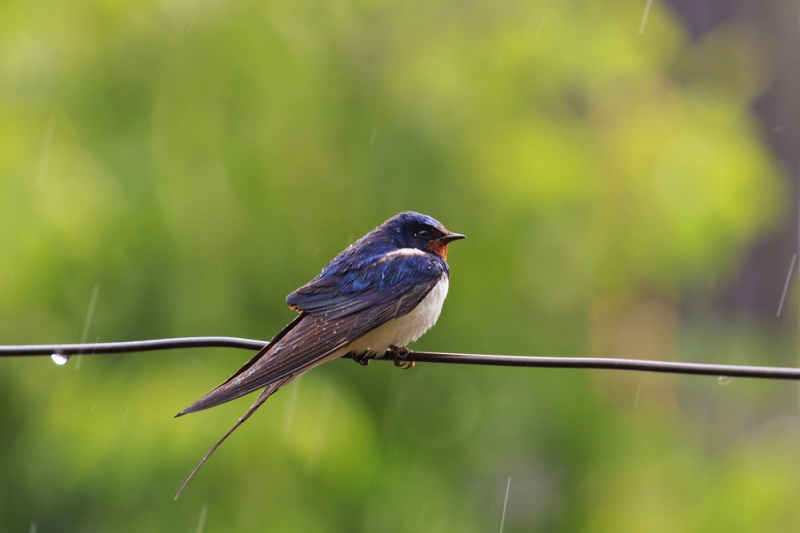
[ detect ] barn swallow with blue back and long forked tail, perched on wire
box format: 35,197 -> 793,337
175,211 -> 465,499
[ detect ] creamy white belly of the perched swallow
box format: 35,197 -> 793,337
334,275 -> 449,357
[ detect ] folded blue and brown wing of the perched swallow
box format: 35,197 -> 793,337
180,253 -> 447,415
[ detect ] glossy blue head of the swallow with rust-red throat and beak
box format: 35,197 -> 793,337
381,211 -> 466,259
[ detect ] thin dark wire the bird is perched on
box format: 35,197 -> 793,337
0,337 -> 800,380
